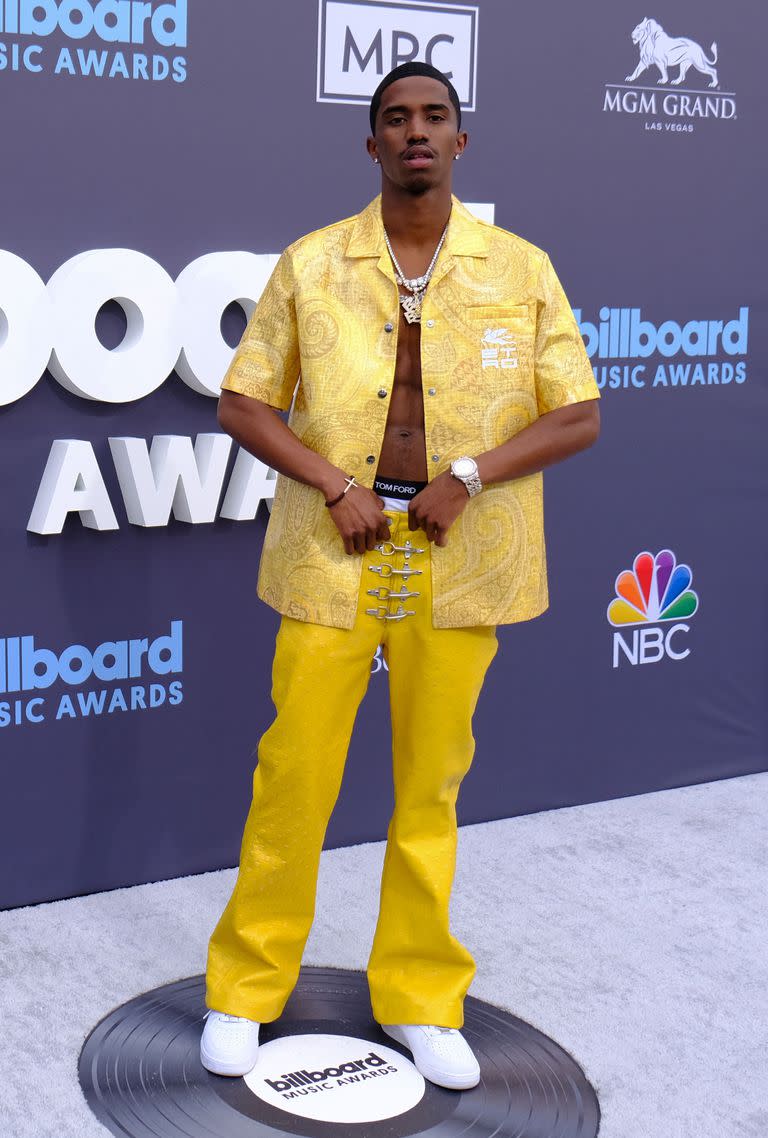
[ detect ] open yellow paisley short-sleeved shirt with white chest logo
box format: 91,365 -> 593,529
222,197 -> 600,628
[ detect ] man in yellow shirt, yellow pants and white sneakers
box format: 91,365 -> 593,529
201,57 -> 598,1089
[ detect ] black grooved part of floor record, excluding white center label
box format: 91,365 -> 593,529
80,967 -> 600,1138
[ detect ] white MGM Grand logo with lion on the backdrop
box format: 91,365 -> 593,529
603,18 -> 736,132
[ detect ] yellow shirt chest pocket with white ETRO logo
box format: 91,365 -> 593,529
468,303 -> 536,387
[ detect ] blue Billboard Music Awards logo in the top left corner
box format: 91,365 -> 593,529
0,0 -> 187,83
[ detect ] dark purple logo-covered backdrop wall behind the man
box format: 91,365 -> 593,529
0,0 -> 768,906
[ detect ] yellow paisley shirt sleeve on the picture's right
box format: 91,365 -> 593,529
534,255 -> 600,414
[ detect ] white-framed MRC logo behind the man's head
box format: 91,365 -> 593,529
317,0 -> 478,110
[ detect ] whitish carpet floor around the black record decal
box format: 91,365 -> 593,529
0,774 -> 768,1138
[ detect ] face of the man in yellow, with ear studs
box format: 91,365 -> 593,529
368,75 -> 466,193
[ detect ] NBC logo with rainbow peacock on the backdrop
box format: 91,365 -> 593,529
608,550 -> 699,668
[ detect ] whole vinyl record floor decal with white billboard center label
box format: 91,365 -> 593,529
80,967 -> 600,1138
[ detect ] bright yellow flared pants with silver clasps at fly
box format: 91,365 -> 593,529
206,511 -> 497,1028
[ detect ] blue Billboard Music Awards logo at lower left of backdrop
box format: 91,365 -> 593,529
0,620 -> 184,727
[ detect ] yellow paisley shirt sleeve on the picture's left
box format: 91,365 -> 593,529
222,250 -> 299,411
